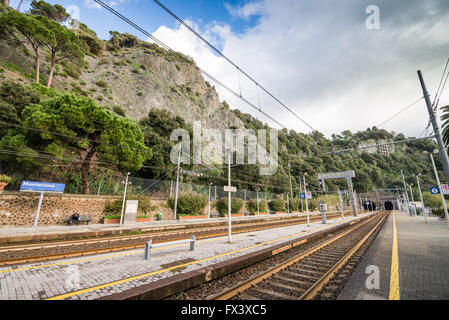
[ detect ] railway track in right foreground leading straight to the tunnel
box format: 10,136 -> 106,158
208,213 -> 388,300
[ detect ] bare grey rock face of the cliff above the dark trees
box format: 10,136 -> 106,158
81,48 -> 243,128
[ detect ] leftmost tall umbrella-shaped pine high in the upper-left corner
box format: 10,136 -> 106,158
0,10 -> 50,83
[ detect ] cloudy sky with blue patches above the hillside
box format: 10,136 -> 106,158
12,0 -> 449,136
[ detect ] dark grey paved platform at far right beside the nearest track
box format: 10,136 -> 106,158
339,211 -> 449,300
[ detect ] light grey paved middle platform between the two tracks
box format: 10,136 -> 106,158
0,213 -> 372,300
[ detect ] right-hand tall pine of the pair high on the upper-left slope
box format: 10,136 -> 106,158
37,16 -> 84,88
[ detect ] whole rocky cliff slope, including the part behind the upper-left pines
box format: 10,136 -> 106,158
0,33 -> 243,129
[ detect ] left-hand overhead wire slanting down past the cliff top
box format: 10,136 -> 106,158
94,0 -> 286,128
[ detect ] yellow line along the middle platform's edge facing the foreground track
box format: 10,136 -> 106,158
45,227 -> 324,300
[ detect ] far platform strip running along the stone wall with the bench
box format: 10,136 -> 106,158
0,212 -> 334,244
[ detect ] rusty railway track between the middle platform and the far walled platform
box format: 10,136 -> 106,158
0,213 -> 341,266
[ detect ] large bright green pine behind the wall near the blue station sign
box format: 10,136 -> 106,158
23,94 -> 151,194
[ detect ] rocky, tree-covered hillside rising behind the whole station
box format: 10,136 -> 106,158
0,1 -> 441,208
